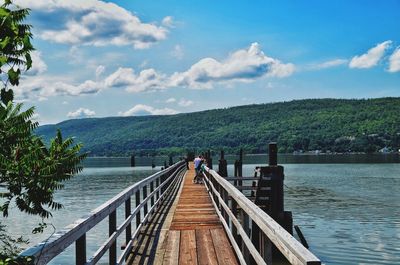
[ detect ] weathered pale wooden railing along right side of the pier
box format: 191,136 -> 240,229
203,167 -> 321,265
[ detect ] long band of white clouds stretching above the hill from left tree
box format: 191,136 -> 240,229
16,43 -> 295,99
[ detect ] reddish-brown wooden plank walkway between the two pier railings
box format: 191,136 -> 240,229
162,164 -> 238,265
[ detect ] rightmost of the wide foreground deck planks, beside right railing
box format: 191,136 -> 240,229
210,228 -> 237,265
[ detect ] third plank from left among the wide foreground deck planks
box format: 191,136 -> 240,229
196,229 -> 218,265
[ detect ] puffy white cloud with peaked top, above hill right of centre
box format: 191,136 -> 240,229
171,43 -> 295,88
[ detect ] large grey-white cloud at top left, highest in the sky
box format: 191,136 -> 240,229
16,0 -> 168,49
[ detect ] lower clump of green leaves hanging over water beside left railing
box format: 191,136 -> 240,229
0,102 -> 85,218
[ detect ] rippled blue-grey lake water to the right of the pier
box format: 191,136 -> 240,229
238,164 -> 400,265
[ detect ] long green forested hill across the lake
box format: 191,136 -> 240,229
37,98 -> 400,156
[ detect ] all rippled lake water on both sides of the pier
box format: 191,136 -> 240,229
2,156 -> 400,265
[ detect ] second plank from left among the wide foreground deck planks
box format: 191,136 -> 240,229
179,230 -> 197,265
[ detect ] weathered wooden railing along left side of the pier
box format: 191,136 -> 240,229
20,161 -> 186,265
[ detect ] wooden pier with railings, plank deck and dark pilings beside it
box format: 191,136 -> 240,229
20,144 -> 321,265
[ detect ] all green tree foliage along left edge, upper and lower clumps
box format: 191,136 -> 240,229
0,1 -> 86,264
